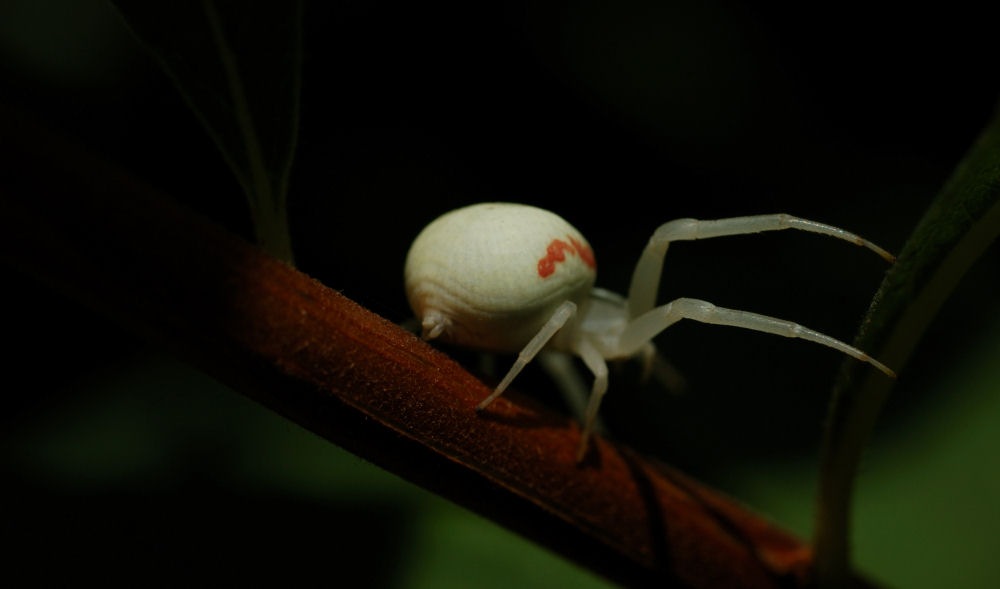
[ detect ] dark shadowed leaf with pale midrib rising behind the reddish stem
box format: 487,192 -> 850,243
112,0 -> 302,262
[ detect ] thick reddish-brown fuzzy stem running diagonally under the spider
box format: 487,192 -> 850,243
0,111 -> 868,587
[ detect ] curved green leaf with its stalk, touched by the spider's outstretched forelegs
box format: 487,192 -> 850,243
815,103 -> 1000,586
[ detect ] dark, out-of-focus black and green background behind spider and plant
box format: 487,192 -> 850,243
0,0 -> 1000,587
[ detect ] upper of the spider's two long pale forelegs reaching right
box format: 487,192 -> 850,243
628,213 -> 895,319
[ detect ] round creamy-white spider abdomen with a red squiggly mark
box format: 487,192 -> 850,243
405,203 -> 596,351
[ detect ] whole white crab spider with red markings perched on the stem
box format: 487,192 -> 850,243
405,203 -> 895,460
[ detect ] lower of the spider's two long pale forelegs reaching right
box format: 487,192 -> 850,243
619,298 -> 896,378
